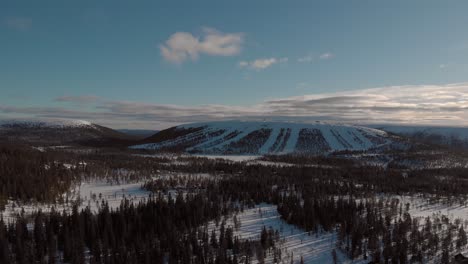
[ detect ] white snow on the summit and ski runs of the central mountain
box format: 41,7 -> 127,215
132,121 -> 391,155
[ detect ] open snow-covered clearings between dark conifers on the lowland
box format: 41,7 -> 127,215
1,179 -> 468,264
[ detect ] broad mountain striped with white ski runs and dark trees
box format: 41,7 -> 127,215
132,121 -> 392,155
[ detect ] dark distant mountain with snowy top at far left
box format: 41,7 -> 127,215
0,118 -> 135,145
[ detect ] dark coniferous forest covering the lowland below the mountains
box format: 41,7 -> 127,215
0,145 -> 468,263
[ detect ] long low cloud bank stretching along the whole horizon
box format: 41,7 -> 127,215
0,83 -> 468,129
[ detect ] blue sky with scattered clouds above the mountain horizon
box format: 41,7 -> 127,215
0,0 -> 468,129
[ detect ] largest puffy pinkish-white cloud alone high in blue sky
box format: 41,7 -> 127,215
159,28 -> 244,64
